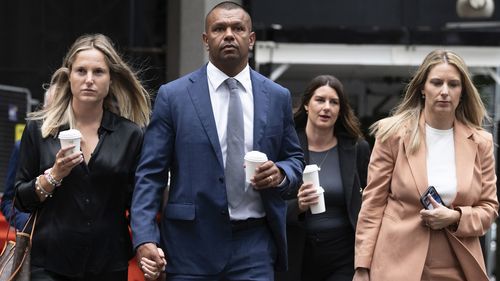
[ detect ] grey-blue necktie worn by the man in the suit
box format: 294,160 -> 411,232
224,78 -> 245,208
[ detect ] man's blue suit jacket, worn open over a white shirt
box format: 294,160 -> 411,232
131,65 -> 304,274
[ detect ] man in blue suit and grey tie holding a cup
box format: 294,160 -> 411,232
131,2 -> 304,281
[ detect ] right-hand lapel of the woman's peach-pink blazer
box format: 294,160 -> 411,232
454,121 -> 477,201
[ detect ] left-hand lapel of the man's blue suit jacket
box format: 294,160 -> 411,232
187,66 -> 224,168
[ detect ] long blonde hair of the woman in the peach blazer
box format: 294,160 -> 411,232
370,50 -> 490,153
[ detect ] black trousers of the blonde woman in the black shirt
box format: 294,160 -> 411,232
31,265 -> 128,281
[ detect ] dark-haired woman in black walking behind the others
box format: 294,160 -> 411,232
277,75 -> 370,281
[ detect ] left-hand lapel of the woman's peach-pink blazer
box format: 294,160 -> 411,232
403,114 -> 428,194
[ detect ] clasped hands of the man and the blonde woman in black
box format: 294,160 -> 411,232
136,243 -> 167,281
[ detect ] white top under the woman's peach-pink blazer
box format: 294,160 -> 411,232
425,124 -> 457,206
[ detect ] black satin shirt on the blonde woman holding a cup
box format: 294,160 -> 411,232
15,111 -> 143,277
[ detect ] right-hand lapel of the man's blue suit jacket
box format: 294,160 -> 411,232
250,69 -> 269,150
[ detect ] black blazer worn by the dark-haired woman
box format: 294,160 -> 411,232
276,130 -> 370,281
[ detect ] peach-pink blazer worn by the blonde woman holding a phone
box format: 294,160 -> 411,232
355,114 -> 498,281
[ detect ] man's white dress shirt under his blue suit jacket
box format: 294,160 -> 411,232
207,62 -> 266,220
